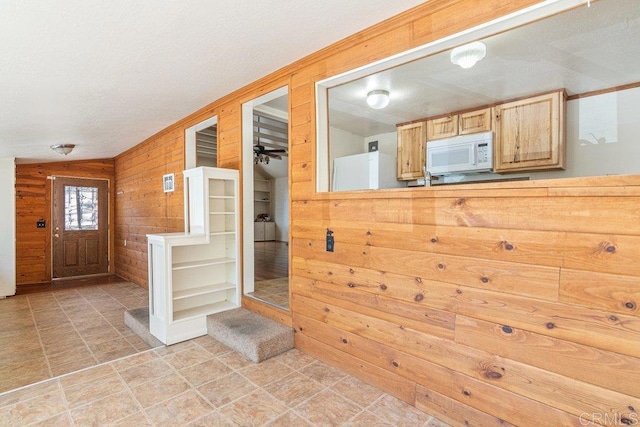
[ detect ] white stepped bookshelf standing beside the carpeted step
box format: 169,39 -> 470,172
147,167 -> 241,345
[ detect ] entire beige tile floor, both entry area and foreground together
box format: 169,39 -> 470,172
0,279 -> 445,427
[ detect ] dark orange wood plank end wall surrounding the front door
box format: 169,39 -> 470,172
16,159 -> 115,286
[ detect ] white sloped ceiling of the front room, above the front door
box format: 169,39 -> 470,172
0,0 -> 424,163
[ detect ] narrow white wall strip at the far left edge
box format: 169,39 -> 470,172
0,157 -> 15,297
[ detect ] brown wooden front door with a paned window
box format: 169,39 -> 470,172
53,177 -> 109,278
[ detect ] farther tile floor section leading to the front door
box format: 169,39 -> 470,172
0,282 -> 150,392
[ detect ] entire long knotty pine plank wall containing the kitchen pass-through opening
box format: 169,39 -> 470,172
116,0 -> 640,426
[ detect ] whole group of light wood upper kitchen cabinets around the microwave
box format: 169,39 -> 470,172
398,90 -> 566,181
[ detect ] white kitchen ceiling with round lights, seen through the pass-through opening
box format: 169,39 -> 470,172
329,0 -> 640,136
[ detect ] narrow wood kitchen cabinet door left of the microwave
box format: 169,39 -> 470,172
398,122 -> 427,181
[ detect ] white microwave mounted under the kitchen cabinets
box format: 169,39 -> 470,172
427,132 -> 493,175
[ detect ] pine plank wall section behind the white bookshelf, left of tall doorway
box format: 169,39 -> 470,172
115,103 -> 241,288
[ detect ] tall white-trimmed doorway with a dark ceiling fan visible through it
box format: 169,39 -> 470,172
242,87 -> 289,310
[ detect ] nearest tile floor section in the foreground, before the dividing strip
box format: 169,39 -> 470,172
0,336 -> 445,427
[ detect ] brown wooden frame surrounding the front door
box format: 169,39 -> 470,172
44,174 -> 115,282
